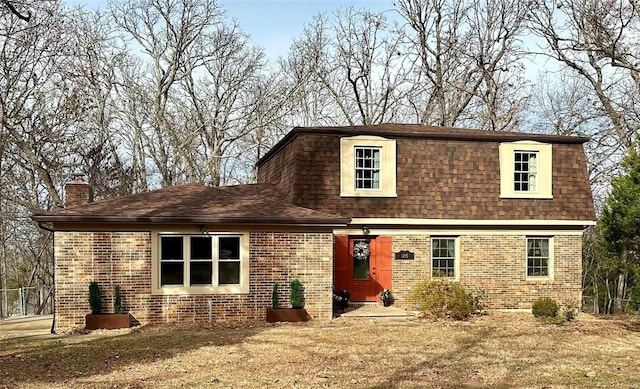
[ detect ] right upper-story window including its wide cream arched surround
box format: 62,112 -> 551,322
499,141 -> 553,199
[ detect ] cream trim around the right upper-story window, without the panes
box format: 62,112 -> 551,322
499,141 -> 553,199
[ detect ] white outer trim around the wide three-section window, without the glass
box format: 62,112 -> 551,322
151,229 -> 249,295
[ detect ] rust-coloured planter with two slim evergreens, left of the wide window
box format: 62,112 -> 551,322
85,281 -> 130,330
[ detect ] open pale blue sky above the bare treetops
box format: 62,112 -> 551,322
63,0 -> 393,59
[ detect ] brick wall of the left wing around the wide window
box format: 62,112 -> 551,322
55,231 -> 333,332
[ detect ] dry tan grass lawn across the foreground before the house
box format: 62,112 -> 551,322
0,313 -> 640,389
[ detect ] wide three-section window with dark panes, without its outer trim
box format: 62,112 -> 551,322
159,235 -> 241,287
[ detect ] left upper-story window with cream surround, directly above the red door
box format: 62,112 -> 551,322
340,136 -> 397,197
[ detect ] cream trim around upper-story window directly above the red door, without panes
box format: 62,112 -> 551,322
340,135 -> 398,197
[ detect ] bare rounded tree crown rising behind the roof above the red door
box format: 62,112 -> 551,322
282,8 -> 408,125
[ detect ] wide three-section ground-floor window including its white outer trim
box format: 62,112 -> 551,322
152,233 -> 249,294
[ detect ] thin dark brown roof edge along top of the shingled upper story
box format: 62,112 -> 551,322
256,123 -> 589,166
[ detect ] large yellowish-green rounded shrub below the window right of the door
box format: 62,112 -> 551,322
409,280 -> 485,320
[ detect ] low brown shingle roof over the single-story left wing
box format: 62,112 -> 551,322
32,183 -> 349,226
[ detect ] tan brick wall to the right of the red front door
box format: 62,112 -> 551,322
392,235 -> 582,309
